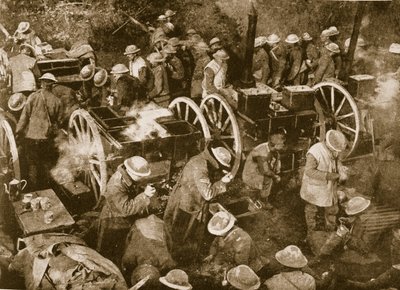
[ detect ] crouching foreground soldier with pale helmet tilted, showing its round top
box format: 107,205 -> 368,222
204,211 -> 268,276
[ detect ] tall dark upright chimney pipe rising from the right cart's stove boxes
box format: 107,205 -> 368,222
241,0 -> 257,88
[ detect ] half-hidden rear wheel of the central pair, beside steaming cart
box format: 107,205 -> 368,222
168,97 -> 211,141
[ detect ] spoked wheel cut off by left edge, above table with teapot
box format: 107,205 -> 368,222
0,118 -> 21,180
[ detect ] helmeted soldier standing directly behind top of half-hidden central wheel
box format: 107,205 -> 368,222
162,45 -> 185,98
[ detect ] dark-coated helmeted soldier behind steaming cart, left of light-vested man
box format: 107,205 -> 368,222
110,64 -> 144,110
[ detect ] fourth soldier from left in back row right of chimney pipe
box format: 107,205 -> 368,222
301,32 -> 319,84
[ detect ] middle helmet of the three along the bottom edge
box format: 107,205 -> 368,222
227,265 -> 261,290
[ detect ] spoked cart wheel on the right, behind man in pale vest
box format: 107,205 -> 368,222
313,82 -> 361,157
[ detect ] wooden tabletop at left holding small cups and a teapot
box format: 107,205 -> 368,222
13,189 -> 75,236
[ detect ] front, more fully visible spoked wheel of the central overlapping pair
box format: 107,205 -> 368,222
200,95 -> 242,176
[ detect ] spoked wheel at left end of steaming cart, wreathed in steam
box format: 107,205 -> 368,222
68,109 -> 108,201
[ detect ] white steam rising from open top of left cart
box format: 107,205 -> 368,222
121,103 -> 172,141
